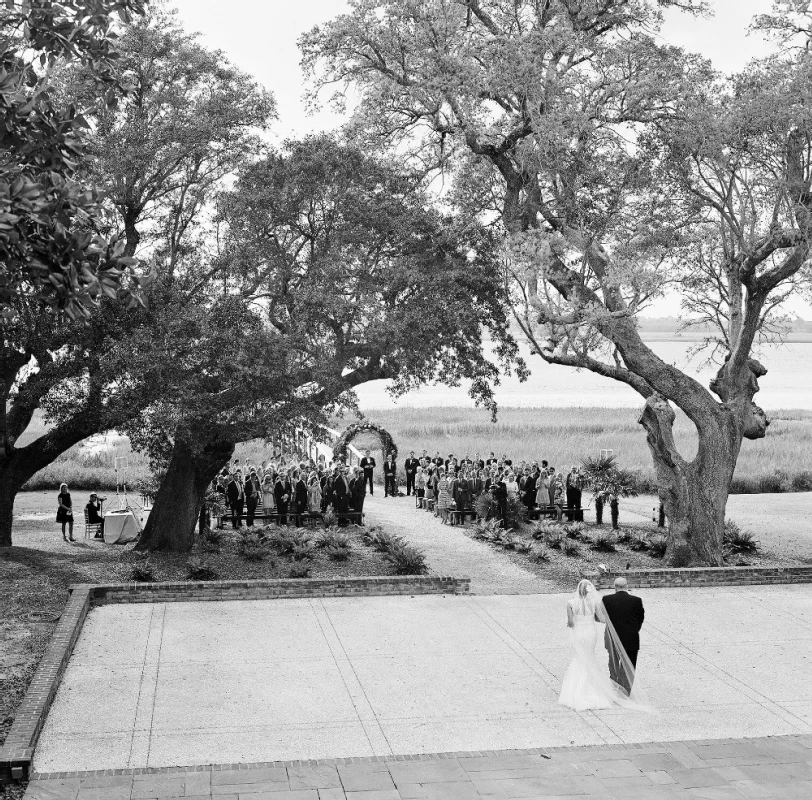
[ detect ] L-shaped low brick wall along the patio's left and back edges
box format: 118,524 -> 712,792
0,575 -> 471,785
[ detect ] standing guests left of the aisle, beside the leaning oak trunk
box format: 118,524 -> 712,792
211,455 -> 366,528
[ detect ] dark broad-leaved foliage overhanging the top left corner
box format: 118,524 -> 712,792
0,0 -> 144,321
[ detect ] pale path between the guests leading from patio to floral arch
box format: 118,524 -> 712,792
364,494 -> 560,594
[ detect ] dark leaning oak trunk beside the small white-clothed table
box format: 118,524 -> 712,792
136,439 -> 234,553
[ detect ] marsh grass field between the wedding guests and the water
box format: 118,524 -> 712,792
21,407 -> 812,493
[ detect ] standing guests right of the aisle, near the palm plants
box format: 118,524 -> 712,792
404,450 -> 584,524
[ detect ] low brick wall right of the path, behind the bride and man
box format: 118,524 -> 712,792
590,565 -> 812,589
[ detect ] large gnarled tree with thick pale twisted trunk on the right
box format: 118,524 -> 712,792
301,0 -> 812,564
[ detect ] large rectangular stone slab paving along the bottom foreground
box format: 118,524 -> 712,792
25,736 -> 812,800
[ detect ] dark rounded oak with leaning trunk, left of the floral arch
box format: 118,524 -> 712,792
127,136 -> 516,550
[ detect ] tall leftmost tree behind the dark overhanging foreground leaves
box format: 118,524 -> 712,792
0,10 -> 274,546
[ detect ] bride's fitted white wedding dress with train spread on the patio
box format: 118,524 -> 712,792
558,598 -> 641,711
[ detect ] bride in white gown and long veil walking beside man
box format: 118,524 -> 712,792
558,580 -> 651,711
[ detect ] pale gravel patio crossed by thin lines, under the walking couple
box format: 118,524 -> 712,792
28,586 -> 812,772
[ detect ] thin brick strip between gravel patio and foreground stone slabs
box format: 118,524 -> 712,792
25,733 -> 812,781
